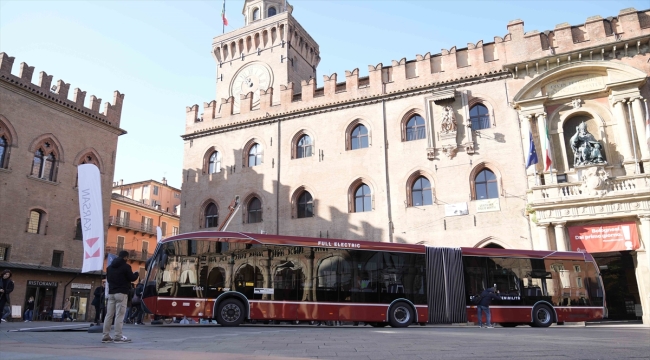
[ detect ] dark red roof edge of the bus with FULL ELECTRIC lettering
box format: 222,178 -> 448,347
160,230 -> 594,261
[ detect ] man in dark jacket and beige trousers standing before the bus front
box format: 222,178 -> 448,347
102,250 -> 139,343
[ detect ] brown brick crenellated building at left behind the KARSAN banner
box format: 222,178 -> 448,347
0,53 -> 126,320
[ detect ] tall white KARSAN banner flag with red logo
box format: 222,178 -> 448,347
77,164 -> 104,273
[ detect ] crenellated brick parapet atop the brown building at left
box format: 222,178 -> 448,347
0,52 -> 124,128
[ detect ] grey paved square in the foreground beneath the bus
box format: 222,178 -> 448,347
0,323 -> 650,360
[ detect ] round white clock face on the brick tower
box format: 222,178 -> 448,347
230,62 -> 273,112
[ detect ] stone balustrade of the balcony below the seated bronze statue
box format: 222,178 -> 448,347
532,174 -> 650,204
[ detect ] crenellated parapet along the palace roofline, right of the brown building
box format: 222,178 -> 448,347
186,8 -> 650,135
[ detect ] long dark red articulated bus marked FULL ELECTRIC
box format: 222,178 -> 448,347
143,231 -> 605,327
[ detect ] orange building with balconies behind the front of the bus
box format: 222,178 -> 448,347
104,179 -> 181,280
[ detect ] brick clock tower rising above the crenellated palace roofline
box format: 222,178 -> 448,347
212,0 -> 320,113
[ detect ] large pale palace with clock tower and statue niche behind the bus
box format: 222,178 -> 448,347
181,0 -> 650,324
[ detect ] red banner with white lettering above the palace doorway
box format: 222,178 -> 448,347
569,221 -> 639,253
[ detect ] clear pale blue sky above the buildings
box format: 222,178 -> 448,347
0,0 -> 650,187
